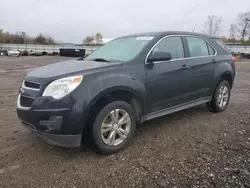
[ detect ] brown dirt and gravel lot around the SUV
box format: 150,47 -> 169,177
0,57 -> 250,188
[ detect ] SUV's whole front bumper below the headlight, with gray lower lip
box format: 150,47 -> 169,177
17,93 -> 85,147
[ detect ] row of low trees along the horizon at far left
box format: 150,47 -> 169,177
0,29 -> 56,44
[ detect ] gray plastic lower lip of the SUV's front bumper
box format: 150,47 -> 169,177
23,122 -> 82,148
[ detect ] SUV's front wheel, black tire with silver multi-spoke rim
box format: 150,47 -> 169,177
92,101 -> 136,154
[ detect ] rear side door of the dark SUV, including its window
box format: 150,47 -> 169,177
184,36 -> 217,100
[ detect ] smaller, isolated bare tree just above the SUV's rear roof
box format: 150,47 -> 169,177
204,14 -> 223,35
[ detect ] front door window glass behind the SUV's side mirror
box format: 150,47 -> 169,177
152,37 -> 184,59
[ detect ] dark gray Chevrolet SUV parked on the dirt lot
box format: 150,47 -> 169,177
17,32 -> 235,154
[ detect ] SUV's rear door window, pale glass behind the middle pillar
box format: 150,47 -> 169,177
186,37 -> 209,57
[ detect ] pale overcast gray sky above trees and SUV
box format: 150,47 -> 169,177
0,0 -> 250,43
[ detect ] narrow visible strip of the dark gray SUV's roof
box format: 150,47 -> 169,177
118,31 -> 217,38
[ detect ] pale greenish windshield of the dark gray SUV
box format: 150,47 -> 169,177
86,36 -> 153,62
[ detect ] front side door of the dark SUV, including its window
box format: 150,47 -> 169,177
146,36 -> 190,112
